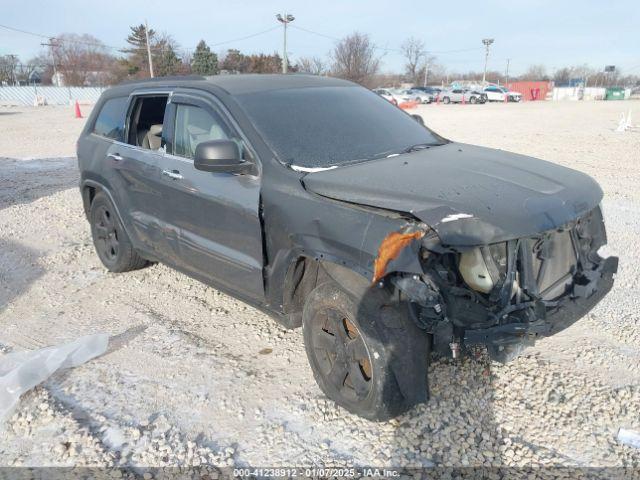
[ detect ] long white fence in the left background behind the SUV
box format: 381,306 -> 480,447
0,86 -> 105,105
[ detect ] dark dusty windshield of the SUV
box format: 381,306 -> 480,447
235,87 -> 445,168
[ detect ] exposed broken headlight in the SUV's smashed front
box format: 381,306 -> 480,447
458,243 -> 507,293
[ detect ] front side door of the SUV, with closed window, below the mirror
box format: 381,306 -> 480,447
160,91 -> 264,300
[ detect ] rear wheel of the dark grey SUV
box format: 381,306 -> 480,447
89,192 -> 149,273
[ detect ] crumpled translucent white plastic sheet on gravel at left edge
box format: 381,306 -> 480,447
0,333 -> 109,422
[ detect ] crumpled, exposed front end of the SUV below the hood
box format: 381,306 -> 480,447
382,207 -> 618,360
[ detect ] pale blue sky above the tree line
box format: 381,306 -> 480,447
0,0 -> 640,75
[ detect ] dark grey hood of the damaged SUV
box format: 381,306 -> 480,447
302,143 -> 602,246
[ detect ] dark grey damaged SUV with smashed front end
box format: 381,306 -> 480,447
78,75 -> 618,420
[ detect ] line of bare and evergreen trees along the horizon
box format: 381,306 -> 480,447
0,24 -> 640,87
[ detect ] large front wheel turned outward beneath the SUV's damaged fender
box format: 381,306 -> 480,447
302,281 -> 431,421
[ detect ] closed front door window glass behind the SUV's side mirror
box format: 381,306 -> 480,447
173,104 -> 232,158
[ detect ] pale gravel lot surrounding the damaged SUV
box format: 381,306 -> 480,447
0,102 -> 640,467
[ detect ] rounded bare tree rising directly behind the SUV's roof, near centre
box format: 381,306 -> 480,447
331,32 -> 380,87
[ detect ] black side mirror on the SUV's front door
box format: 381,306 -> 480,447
193,140 -> 253,175
